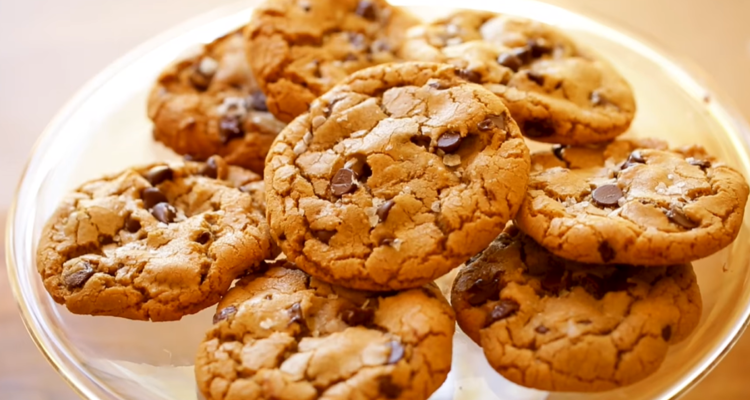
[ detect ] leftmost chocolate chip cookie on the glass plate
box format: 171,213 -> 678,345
37,156 -> 274,321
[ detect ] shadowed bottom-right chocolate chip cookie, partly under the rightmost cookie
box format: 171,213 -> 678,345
451,227 -> 702,392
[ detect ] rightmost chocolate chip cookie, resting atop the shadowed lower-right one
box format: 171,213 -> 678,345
516,139 -> 748,266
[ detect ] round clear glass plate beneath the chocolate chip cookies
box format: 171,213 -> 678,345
7,0 -> 750,400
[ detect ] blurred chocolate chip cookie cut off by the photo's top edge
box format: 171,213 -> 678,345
247,0 -> 418,122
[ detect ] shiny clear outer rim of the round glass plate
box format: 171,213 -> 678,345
5,0 -> 750,399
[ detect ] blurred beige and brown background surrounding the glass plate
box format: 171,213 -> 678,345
0,0 -> 750,400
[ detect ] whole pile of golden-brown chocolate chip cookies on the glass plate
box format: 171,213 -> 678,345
37,0 -> 748,400
